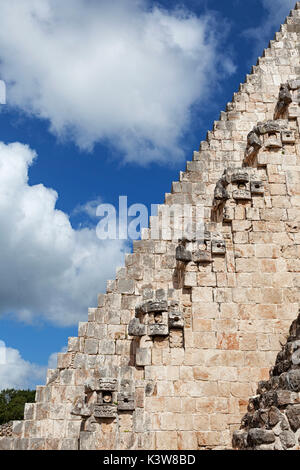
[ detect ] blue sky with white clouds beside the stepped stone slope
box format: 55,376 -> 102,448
0,0 -> 295,388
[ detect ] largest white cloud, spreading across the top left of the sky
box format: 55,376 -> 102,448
0,0 -> 235,164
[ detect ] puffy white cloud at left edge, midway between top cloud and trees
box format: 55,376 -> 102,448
0,143 -> 126,325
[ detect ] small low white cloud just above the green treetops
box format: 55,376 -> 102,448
0,341 -> 47,390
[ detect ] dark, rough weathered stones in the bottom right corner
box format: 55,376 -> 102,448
233,314 -> 300,450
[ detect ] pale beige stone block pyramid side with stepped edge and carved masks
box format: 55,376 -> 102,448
0,2 -> 300,450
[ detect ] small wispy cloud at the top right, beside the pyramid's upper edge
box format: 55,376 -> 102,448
244,0 -> 296,55
